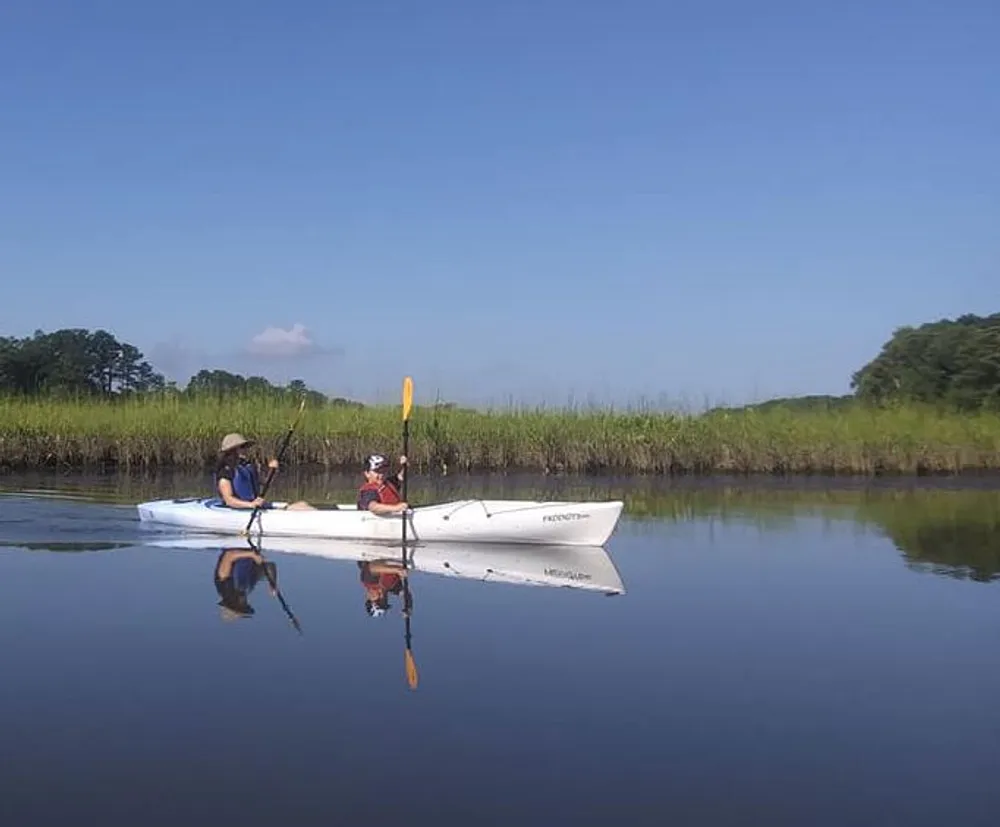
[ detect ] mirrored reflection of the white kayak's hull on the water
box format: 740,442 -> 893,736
144,535 -> 625,594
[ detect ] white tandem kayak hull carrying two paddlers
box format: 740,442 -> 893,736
136,497 -> 622,546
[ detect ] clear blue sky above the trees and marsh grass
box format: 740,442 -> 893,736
0,0 -> 1000,407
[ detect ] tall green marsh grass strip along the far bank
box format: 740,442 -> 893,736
0,397 -> 1000,476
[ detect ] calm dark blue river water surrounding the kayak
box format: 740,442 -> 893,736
0,477 -> 1000,827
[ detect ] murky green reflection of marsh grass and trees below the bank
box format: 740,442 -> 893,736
0,473 -> 1000,582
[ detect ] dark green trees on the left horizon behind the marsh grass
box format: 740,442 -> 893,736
0,328 -> 340,405
